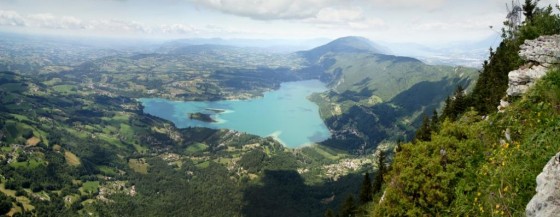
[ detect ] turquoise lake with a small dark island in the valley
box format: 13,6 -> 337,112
139,80 -> 331,148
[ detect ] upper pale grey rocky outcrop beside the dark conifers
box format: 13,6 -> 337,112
507,35 -> 560,96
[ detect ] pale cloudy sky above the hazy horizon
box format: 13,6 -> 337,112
0,0 -> 558,42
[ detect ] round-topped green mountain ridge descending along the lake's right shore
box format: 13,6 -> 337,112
298,37 -> 477,151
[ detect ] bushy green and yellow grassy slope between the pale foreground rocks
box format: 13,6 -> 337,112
373,67 -> 560,216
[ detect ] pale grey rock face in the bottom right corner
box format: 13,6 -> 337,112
525,153 -> 560,217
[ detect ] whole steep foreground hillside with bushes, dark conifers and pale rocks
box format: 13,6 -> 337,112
370,6 -> 560,216
